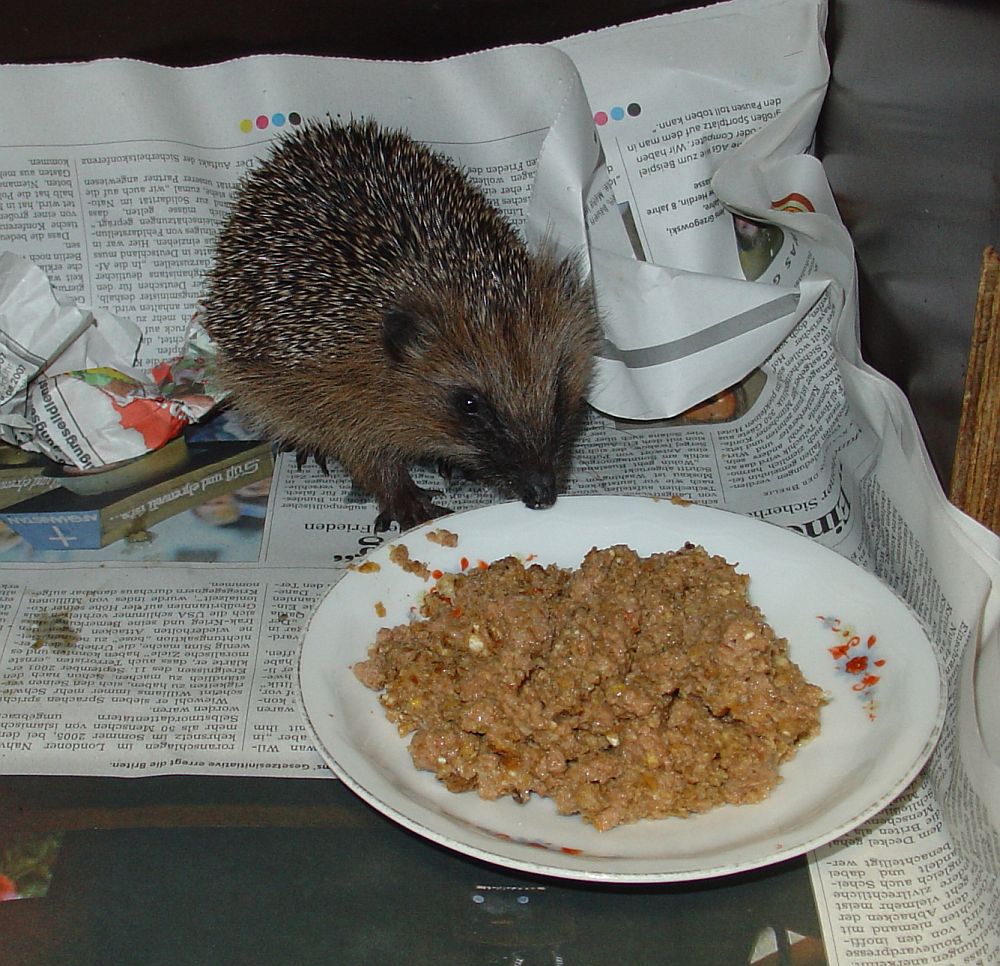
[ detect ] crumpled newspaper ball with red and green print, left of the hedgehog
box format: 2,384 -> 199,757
0,252 -> 224,470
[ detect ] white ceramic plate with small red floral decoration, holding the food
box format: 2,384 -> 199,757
299,497 -> 945,882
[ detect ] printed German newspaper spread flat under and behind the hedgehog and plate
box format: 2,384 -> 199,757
0,0 -> 1000,966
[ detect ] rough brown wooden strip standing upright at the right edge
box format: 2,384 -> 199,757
949,247 -> 1000,534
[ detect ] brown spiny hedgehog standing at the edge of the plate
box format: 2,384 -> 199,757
204,119 -> 600,531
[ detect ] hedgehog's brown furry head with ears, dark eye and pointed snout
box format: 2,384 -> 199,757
383,255 -> 599,507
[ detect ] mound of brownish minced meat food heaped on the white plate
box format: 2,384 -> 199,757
354,544 -> 824,831
